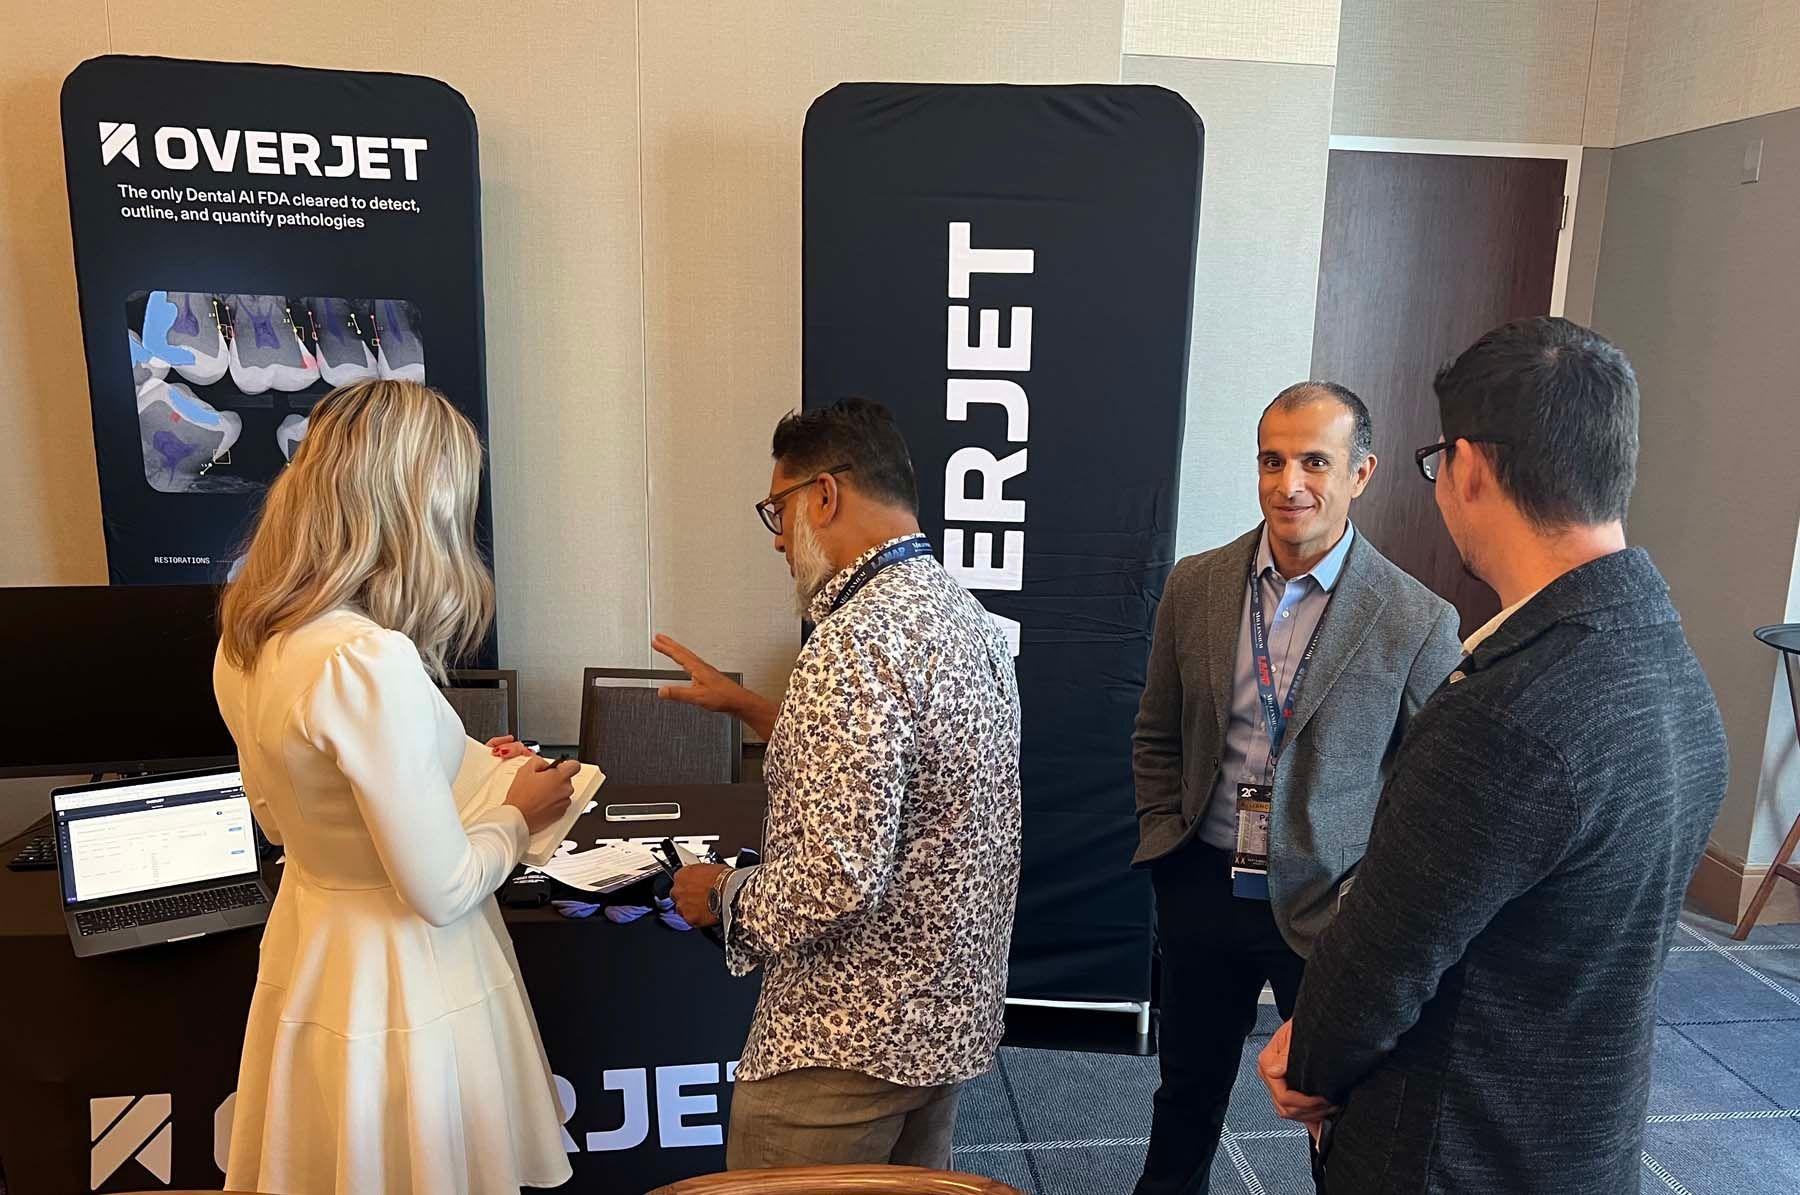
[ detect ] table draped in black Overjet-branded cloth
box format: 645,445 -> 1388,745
0,785 -> 767,1195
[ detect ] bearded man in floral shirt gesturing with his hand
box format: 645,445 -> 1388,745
655,400 -> 1019,1170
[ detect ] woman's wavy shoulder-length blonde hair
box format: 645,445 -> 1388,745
220,380 -> 493,682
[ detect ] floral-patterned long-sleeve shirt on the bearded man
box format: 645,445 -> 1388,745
724,540 -> 1019,1087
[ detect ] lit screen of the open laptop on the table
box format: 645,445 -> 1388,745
54,772 -> 257,905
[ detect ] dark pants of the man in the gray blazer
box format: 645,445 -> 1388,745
1136,842 -> 1307,1195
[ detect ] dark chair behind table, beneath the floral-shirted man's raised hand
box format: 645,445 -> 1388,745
576,668 -> 743,785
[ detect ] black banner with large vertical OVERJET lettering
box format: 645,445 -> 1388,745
803,83 -> 1202,1001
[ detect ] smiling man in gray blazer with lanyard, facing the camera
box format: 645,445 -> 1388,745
1132,382 -> 1458,1195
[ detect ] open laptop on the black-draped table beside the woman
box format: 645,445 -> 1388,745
50,768 -> 274,957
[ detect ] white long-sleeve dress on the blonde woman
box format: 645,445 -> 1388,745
212,610 -> 571,1195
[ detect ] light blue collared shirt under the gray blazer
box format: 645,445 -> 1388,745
1201,524 -> 1355,851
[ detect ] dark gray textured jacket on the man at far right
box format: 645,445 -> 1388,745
1287,549 -> 1726,1195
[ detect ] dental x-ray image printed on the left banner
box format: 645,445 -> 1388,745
126,290 -> 425,493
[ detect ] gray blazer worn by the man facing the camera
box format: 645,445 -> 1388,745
1132,526 -> 1462,957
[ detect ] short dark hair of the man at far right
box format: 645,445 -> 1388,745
1431,315 -> 1638,529
